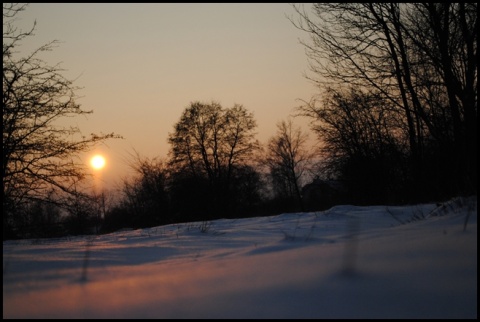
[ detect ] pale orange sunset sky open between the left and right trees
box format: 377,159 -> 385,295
11,3 -> 316,188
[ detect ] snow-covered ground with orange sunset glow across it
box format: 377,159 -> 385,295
3,196 -> 477,319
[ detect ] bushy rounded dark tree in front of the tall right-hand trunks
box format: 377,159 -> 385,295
309,89 -> 408,202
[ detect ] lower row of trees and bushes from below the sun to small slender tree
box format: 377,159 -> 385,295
6,102 -> 315,237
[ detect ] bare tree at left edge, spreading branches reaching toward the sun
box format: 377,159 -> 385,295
2,4 -> 119,238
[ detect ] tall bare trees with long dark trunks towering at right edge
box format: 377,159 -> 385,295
291,3 -> 478,200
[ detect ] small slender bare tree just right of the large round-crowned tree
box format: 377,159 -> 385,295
265,118 -> 315,211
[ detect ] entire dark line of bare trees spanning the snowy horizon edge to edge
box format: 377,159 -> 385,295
2,3 -> 478,239
